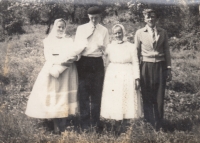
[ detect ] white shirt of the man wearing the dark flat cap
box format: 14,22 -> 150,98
75,23 -> 109,57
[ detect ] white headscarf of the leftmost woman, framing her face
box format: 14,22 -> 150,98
47,18 -> 67,39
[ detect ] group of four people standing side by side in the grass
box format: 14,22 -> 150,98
25,7 -> 172,134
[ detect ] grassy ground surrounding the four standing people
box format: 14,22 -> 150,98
0,23 -> 200,143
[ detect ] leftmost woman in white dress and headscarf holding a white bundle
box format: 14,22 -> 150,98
25,19 -> 78,133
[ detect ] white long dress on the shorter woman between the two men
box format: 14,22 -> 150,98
101,42 -> 142,120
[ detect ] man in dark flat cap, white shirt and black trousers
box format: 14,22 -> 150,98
75,6 -> 109,129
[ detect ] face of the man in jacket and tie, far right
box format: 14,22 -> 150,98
144,12 -> 157,28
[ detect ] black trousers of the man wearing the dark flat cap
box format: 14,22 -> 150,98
76,56 -> 104,126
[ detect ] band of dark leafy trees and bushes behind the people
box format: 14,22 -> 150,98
0,0 -> 200,39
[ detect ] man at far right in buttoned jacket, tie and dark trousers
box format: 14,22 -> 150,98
135,9 -> 172,130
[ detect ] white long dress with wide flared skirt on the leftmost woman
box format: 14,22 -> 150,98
25,38 -> 78,118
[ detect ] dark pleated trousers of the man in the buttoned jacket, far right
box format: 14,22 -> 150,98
140,62 -> 166,129
